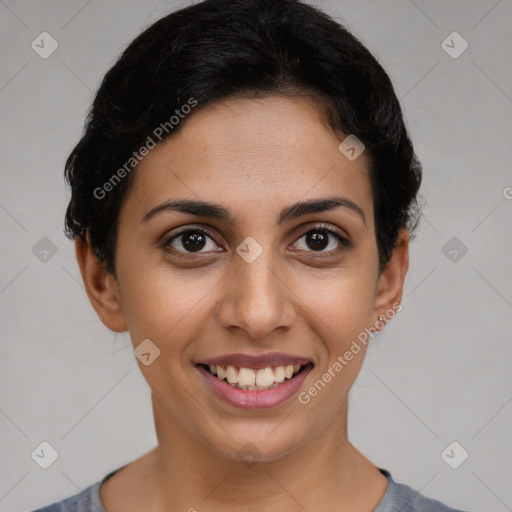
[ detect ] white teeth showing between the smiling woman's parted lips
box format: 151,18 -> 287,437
197,363 -> 313,391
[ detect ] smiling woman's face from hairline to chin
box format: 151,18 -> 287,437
84,96 -> 403,460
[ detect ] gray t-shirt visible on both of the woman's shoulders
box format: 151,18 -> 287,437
32,466 -> 464,512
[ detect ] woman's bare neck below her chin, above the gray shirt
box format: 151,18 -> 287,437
142,390 -> 387,512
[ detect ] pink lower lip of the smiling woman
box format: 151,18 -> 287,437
196,366 -> 313,409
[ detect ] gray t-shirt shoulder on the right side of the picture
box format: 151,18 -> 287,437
374,468 -> 470,512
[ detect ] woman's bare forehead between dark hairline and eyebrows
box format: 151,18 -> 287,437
123,96 -> 373,226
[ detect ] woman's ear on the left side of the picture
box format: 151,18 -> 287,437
75,232 -> 128,332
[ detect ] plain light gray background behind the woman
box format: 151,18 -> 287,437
0,0 -> 512,512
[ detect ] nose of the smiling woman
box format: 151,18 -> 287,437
218,249 -> 297,343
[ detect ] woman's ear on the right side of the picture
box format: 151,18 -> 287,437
373,228 -> 409,325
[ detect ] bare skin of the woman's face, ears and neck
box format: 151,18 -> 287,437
76,96 -> 409,512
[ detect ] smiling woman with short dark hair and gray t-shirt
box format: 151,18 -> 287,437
33,0 -> 468,512
